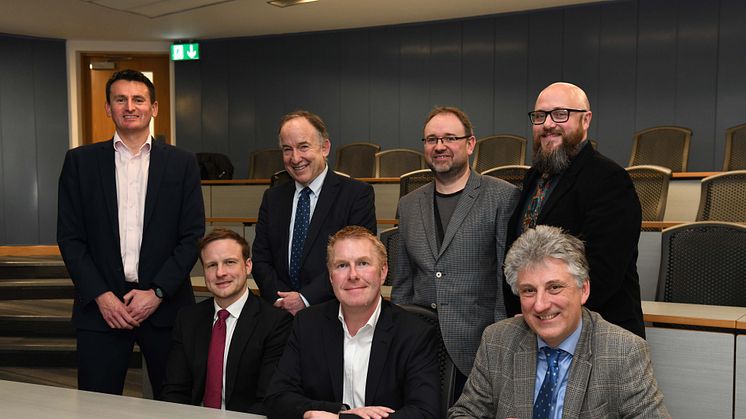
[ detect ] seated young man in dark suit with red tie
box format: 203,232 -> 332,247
163,228 -> 292,414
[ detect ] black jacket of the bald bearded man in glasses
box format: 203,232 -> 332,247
504,144 -> 645,337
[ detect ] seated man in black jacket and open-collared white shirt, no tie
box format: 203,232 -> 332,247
266,226 -> 440,419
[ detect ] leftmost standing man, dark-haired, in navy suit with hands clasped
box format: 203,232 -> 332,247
57,70 -> 205,398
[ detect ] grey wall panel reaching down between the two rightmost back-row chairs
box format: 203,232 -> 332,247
674,0 -> 722,172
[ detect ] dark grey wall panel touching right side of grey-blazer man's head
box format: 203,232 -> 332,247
461,19 -> 496,138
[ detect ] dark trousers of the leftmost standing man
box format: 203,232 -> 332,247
77,320 -> 172,399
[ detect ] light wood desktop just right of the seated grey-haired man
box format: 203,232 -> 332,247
642,301 -> 746,329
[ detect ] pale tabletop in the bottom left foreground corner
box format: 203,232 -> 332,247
0,380 -> 266,419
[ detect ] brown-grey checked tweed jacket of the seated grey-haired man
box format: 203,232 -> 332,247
448,308 -> 670,418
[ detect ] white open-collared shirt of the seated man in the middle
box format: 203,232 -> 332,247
337,298 -> 381,409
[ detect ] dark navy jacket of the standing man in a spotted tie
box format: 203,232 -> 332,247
252,169 -> 376,304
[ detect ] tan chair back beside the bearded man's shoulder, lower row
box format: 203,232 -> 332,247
627,165 -> 671,221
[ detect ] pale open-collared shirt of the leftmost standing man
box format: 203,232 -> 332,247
114,133 -> 153,282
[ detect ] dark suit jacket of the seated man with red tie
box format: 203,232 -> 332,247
161,291 -> 293,414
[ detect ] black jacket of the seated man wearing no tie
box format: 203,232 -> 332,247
265,300 -> 441,419
